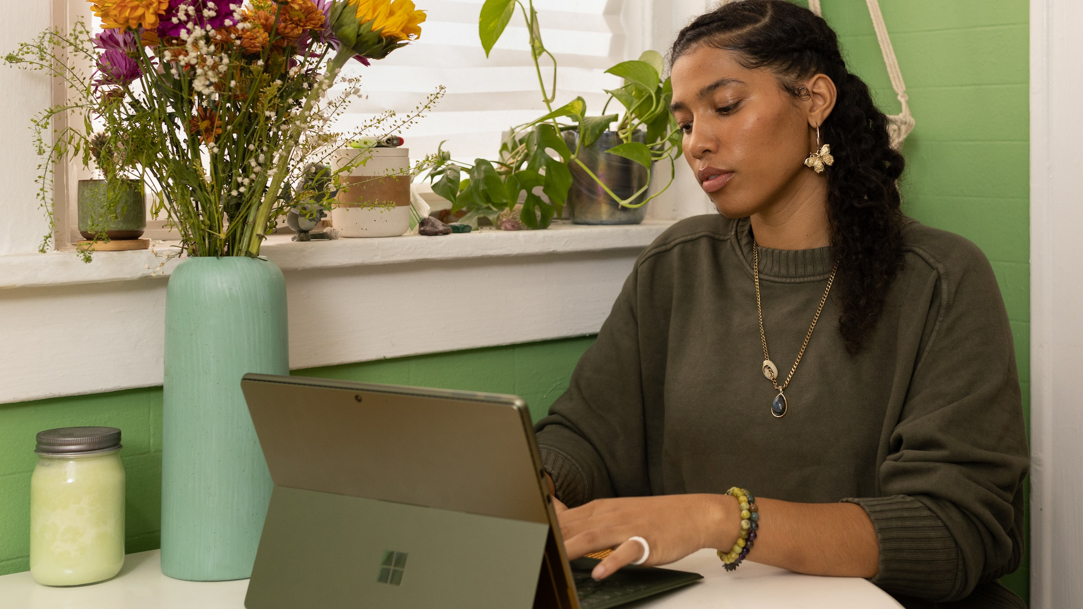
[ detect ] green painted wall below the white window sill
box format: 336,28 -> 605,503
0,337 -> 593,575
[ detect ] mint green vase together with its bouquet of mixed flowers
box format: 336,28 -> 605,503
6,0 -> 439,581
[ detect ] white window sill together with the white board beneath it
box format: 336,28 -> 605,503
0,221 -> 671,404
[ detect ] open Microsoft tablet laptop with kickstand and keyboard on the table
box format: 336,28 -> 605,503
240,374 -> 702,609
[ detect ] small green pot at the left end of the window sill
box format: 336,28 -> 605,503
79,179 -> 146,241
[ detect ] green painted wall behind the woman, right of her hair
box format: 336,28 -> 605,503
801,0 -> 1030,599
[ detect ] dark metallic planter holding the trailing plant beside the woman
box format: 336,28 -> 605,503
565,131 -> 650,224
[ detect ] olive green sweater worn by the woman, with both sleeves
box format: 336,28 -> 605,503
537,216 -> 1028,607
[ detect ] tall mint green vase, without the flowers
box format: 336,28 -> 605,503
161,257 -> 289,581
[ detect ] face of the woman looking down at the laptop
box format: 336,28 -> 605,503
671,44 -> 814,218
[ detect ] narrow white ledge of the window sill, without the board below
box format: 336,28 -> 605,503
0,220 -> 673,289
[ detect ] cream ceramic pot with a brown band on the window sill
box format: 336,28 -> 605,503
331,147 -> 410,237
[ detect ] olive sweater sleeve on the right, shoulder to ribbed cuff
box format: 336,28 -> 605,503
845,243 -> 1029,601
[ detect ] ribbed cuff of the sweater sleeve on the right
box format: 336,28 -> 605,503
843,495 -> 963,600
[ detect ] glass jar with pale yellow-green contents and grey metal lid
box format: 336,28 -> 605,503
30,427 -> 125,586
